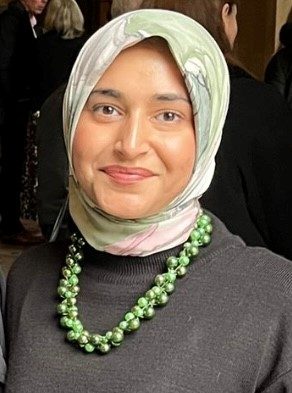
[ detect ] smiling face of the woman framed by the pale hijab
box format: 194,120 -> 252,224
73,43 -> 195,219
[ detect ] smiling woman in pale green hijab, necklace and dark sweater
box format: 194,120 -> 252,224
6,10 -> 292,393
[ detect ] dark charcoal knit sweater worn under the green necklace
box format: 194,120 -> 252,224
6,219 -> 292,393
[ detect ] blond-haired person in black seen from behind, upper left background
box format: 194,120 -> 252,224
36,0 -> 86,109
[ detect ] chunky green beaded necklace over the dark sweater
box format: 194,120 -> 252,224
57,213 -> 212,354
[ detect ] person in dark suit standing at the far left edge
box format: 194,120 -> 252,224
0,0 -> 47,242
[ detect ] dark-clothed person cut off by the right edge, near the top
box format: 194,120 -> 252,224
265,22 -> 292,108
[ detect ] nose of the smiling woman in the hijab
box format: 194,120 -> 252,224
115,112 -> 150,160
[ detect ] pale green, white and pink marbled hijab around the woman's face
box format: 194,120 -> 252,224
63,10 -> 229,256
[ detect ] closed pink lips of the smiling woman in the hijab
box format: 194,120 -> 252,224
100,165 -> 155,184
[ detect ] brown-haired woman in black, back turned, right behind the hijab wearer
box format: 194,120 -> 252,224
140,0 -> 292,259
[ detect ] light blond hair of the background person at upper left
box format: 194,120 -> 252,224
44,0 -> 84,39
